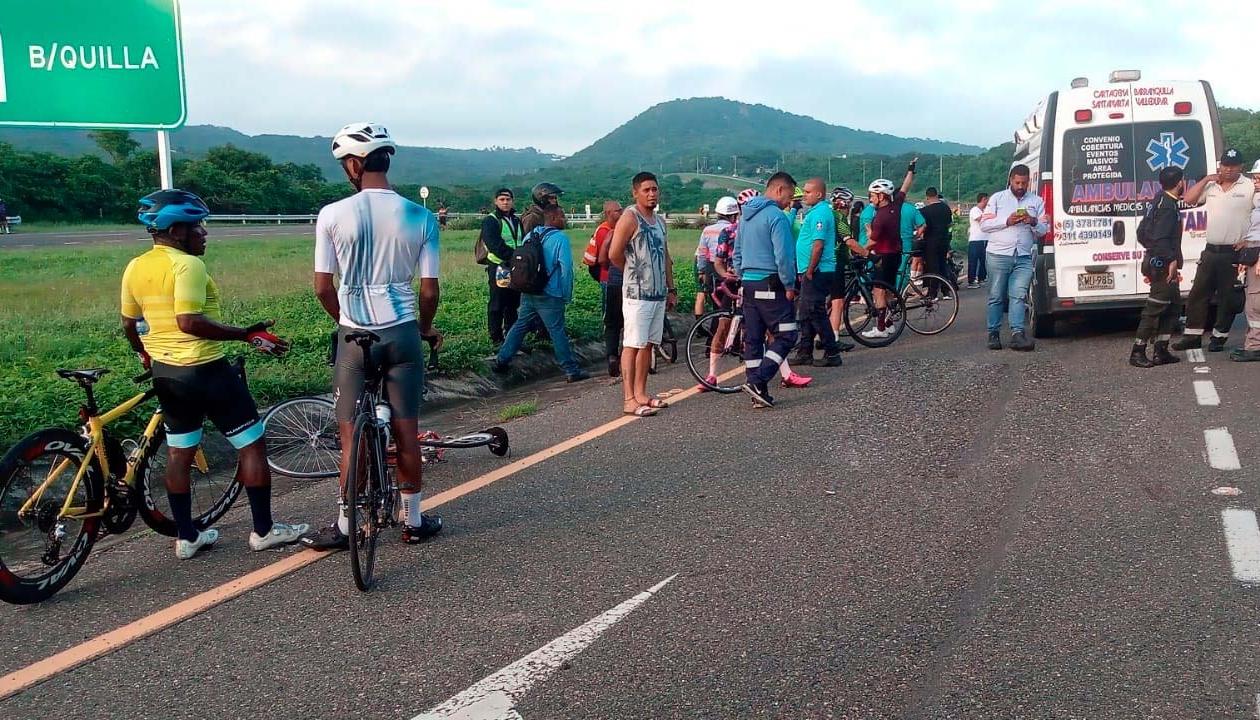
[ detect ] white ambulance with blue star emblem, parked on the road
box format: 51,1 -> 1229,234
1012,71 -> 1223,338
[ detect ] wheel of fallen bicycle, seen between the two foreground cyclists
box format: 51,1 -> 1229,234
262,397 -> 341,478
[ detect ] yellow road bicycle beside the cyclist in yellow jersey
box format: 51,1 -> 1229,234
0,361 -> 243,604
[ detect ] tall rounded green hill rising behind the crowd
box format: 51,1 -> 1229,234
564,97 -> 984,174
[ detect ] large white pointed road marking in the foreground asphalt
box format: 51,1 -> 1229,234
412,575 -> 678,720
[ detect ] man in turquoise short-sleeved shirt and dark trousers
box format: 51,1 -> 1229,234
791,178 -> 844,367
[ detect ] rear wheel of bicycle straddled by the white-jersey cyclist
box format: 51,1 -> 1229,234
345,414 -> 386,593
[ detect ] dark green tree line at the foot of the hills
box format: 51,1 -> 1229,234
0,108 -> 1260,222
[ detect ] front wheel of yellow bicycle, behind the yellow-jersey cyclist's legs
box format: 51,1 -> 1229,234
135,425 -> 242,537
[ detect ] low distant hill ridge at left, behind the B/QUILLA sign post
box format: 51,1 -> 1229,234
0,125 -> 556,184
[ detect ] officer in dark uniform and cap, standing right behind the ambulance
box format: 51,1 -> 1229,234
1129,166 -> 1186,367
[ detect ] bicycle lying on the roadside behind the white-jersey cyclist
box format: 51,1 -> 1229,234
262,395 -> 510,479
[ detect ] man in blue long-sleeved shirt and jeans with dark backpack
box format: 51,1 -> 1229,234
490,206 -> 591,382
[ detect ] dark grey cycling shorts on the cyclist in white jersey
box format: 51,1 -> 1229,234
333,322 -> 425,422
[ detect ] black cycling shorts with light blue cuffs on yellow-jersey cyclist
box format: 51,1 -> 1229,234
152,358 -> 263,450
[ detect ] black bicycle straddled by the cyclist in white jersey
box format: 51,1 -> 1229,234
341,330 -> 398,591
